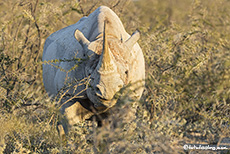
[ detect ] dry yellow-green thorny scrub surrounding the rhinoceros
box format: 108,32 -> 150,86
0,0 -> 230,153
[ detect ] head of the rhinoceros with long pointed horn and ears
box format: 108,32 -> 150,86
75,21 -> 140,110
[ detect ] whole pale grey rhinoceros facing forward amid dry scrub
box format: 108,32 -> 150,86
42,6 -> 145,132
